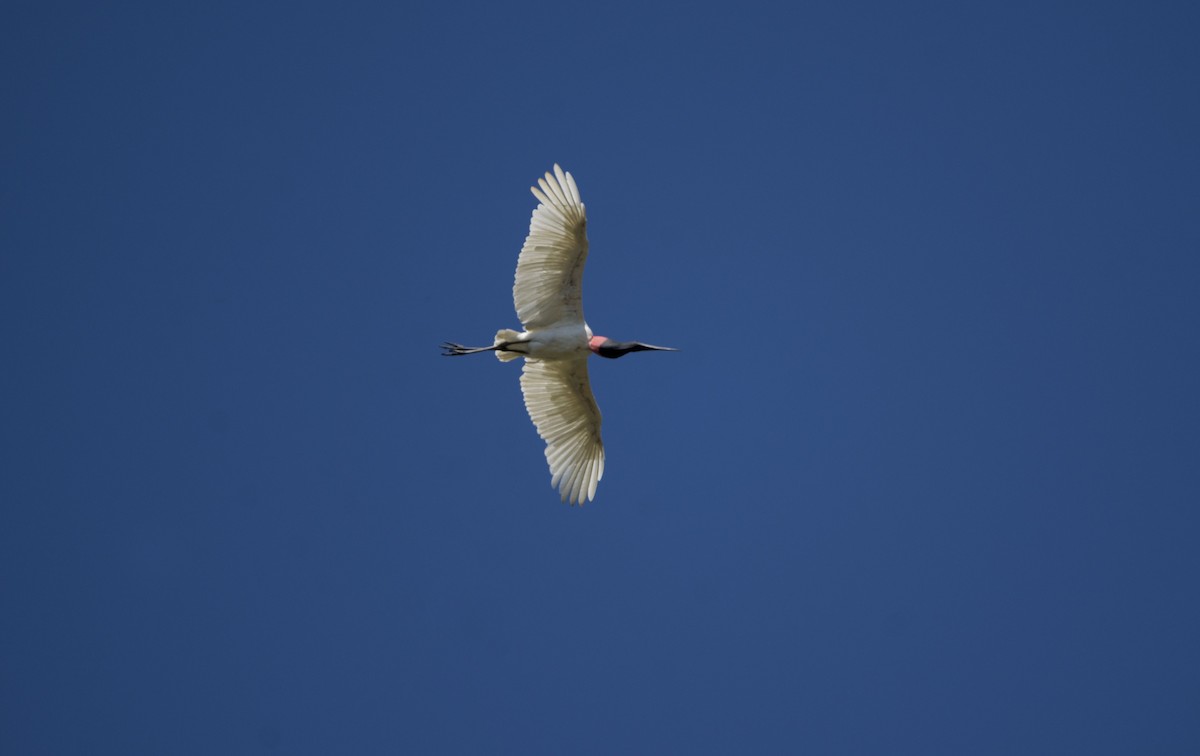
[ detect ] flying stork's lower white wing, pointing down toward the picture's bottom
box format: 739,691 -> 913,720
521,353 -> 604,504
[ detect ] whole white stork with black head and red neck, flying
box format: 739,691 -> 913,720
442,163 -> 676,504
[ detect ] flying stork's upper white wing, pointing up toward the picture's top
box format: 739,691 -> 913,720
512,163 -> 588,330
